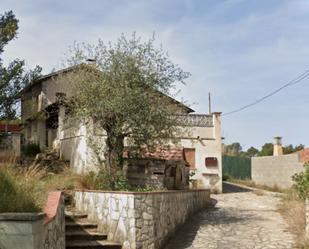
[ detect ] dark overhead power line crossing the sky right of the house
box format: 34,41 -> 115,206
222,69 -> 309,116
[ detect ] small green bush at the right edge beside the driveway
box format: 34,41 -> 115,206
292,163 -> 309,200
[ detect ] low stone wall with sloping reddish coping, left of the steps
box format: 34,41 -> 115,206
43,192 -> 65,249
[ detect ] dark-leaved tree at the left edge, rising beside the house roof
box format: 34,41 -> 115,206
0,11 -> 41,119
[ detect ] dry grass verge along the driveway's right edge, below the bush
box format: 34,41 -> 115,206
278,188 -> 309,249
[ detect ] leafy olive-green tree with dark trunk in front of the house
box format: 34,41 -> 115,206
64,35 -> 189,175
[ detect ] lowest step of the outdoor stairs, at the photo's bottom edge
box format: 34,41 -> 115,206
66,240 -> 122,249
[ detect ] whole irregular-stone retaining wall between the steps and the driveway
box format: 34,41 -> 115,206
75,190 -> 210,249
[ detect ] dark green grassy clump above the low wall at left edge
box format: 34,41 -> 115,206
0,169 -> 41,213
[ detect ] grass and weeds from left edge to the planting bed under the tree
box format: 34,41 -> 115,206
0,153 -> 161,213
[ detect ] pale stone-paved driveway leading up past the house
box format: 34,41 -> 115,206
166,185 -> 295,249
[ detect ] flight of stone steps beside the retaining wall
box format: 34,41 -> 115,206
65,209 -> 122,249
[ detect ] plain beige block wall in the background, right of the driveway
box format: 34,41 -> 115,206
251,154 -> 304,189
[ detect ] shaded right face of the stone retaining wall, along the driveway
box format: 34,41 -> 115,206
135,190 -> 210,249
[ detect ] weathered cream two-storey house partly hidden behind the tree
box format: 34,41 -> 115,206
21,67 -> 222,192
